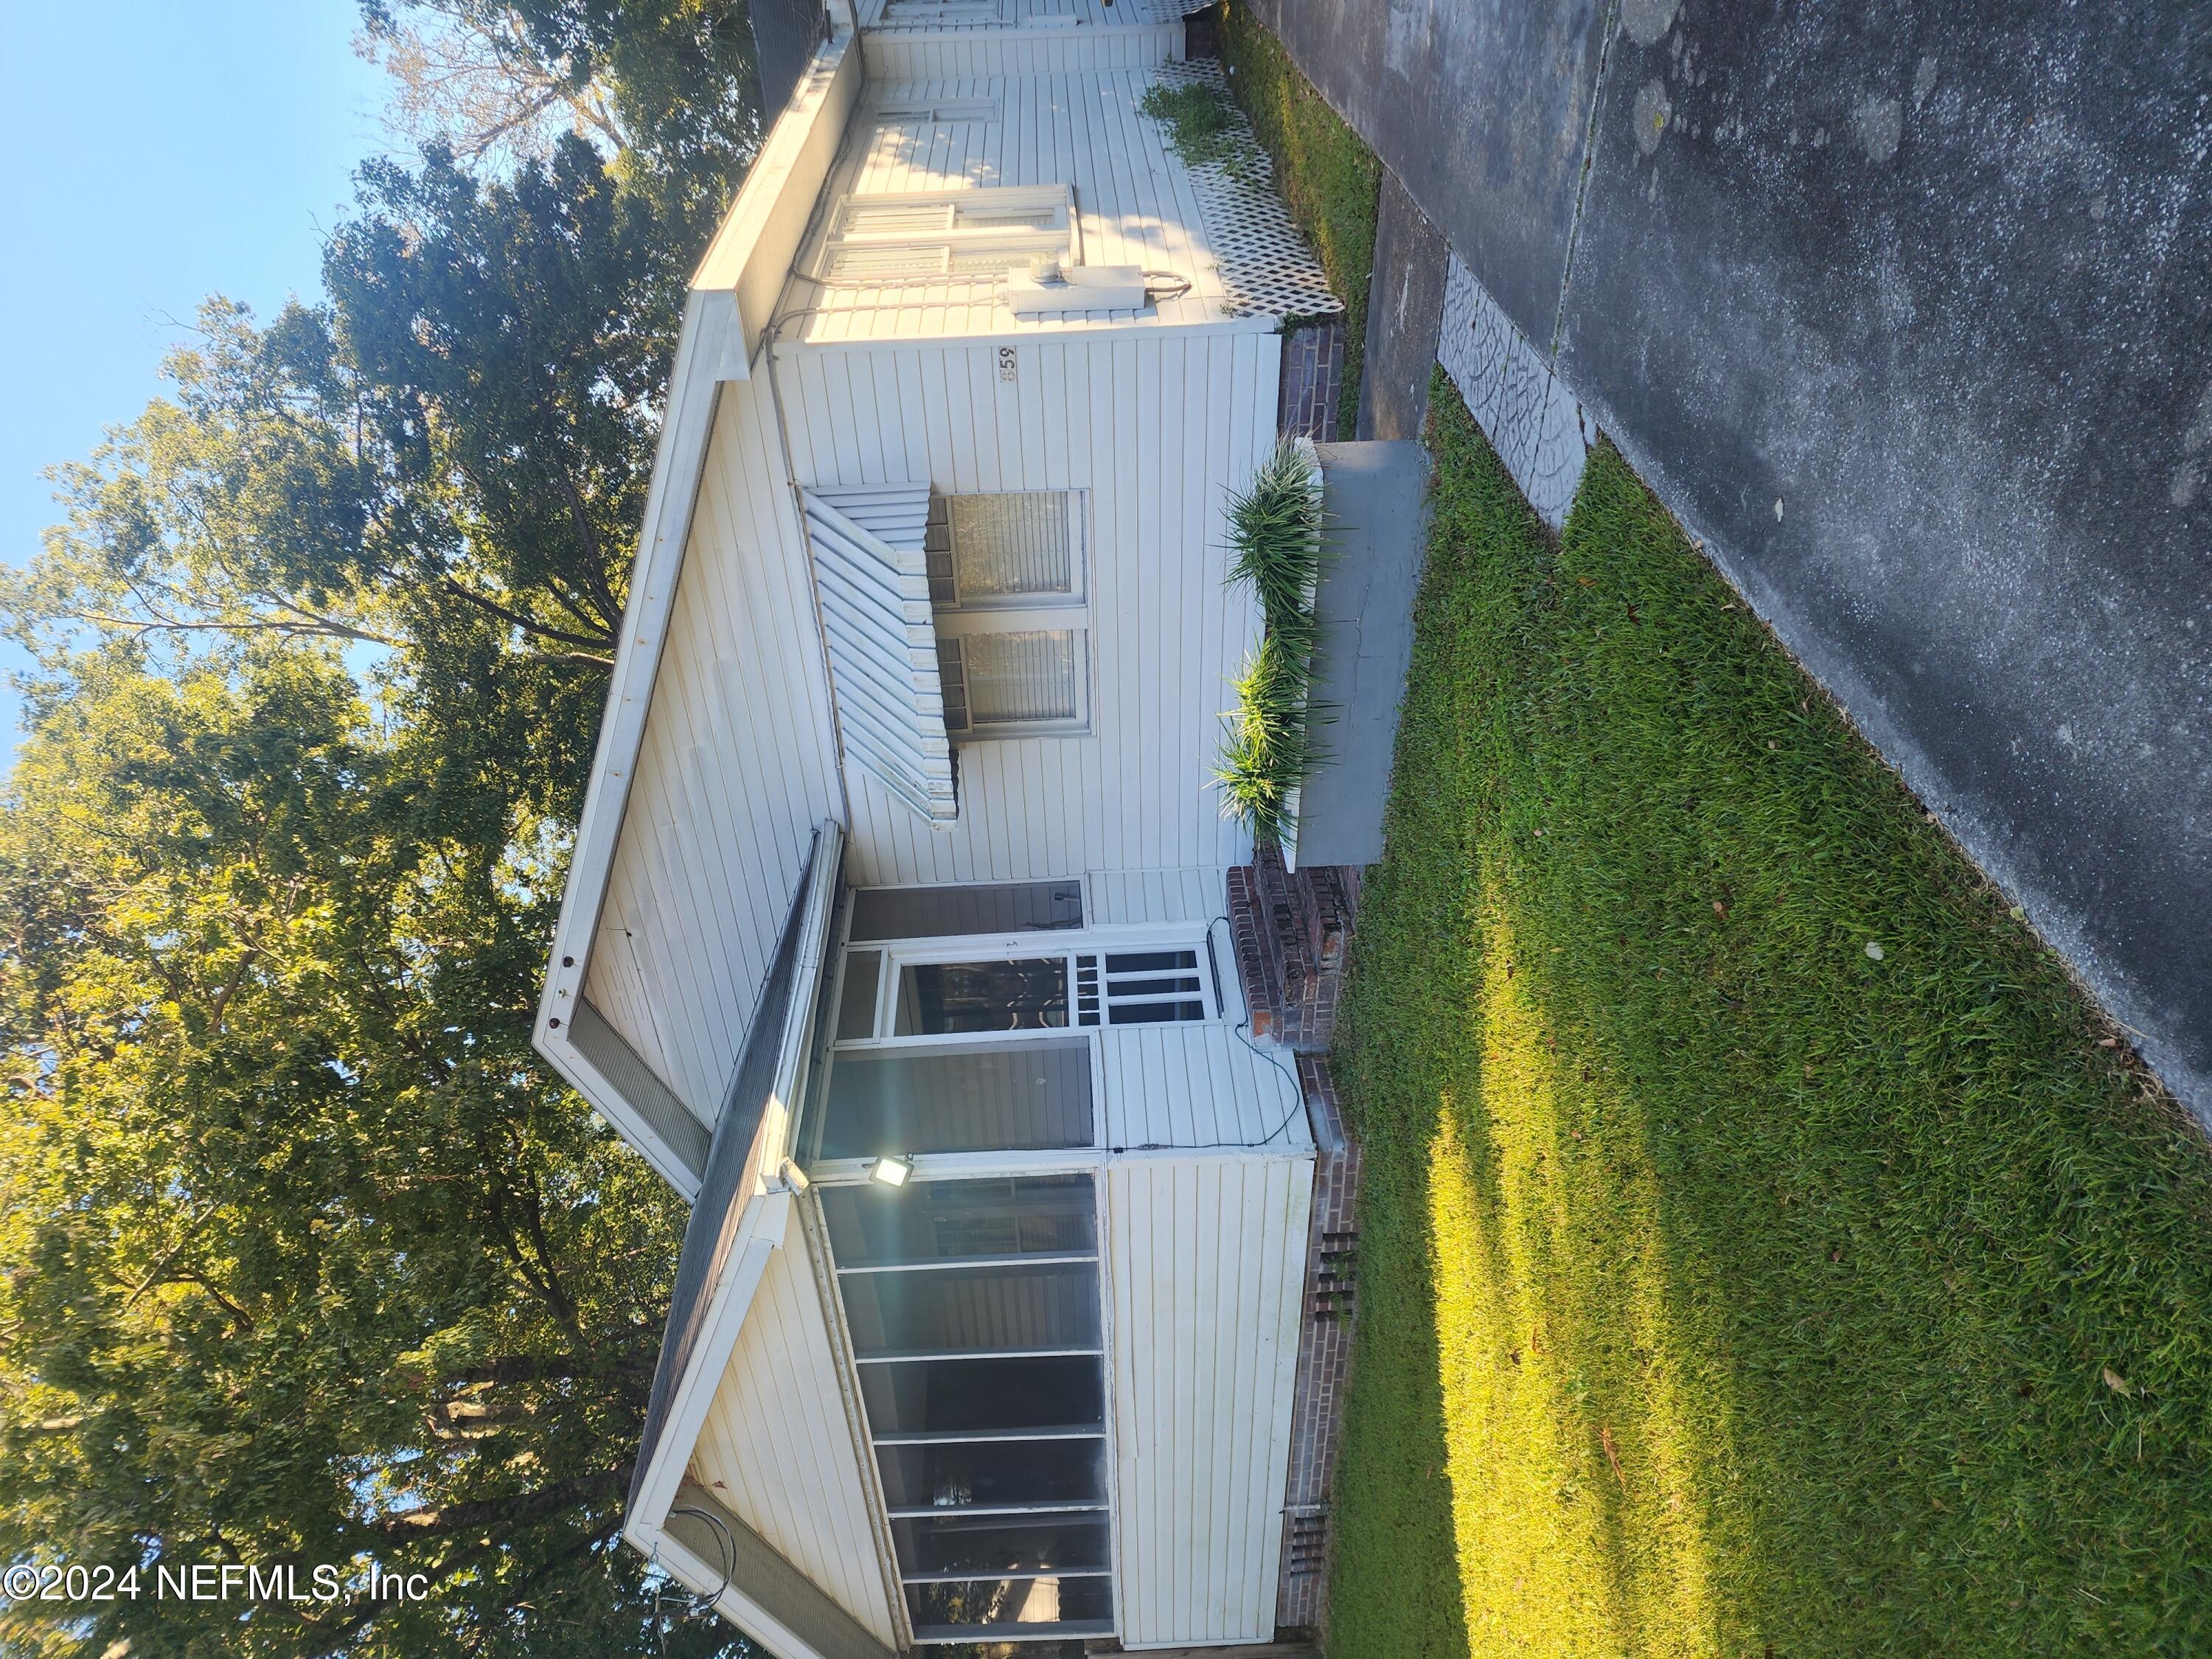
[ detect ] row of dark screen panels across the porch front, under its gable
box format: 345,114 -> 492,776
818,1175 -> 1115,1644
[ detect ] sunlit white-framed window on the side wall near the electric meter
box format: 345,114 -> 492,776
818,184 -> 1082,281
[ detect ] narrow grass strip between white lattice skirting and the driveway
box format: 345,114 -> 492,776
1221,0 -> 1382,438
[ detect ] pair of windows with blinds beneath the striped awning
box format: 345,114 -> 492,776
925,489 -> 1091,739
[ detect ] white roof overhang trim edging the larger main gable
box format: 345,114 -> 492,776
533,33 -> 860,1199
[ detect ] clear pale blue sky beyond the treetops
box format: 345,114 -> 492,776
0,0 -> 392,770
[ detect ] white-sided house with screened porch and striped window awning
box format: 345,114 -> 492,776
538,0 -> 1334,1659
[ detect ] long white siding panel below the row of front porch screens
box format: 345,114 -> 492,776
1106,1157 -> 1314,1648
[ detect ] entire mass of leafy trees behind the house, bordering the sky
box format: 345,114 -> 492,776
0,0 -> 779,1659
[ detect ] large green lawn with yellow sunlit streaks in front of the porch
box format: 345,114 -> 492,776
1327,376 -> 2212,1659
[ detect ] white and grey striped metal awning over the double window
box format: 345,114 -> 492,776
805,484 -> 956,823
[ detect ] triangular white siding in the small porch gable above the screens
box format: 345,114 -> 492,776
690,1219 -> 898,1648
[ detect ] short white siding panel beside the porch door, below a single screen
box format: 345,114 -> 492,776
1099,1022 -> 1314,1155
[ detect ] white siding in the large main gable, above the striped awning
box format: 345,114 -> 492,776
586,378 -> 843,1126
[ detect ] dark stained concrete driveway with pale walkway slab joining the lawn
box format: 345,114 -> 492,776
1252,0 -> 2212,1121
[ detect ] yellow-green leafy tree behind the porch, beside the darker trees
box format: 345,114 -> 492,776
0,641 -> 734,1655
